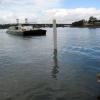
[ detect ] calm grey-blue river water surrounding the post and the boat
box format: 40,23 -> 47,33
0,28 -> 100,100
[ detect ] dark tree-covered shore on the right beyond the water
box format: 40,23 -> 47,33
71,16 -> 100,28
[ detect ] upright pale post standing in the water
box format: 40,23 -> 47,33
53,19 -> 57,51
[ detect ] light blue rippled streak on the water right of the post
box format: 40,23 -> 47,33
62,46 -> 100,59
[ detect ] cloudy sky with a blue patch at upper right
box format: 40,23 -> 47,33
0,0 -> 100,24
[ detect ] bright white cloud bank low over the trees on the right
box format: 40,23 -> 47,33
39,8 -> 100,23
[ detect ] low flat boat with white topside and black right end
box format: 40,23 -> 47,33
7,25 -> 46,36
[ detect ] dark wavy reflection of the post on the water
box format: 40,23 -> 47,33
52,50 -> 59,79
